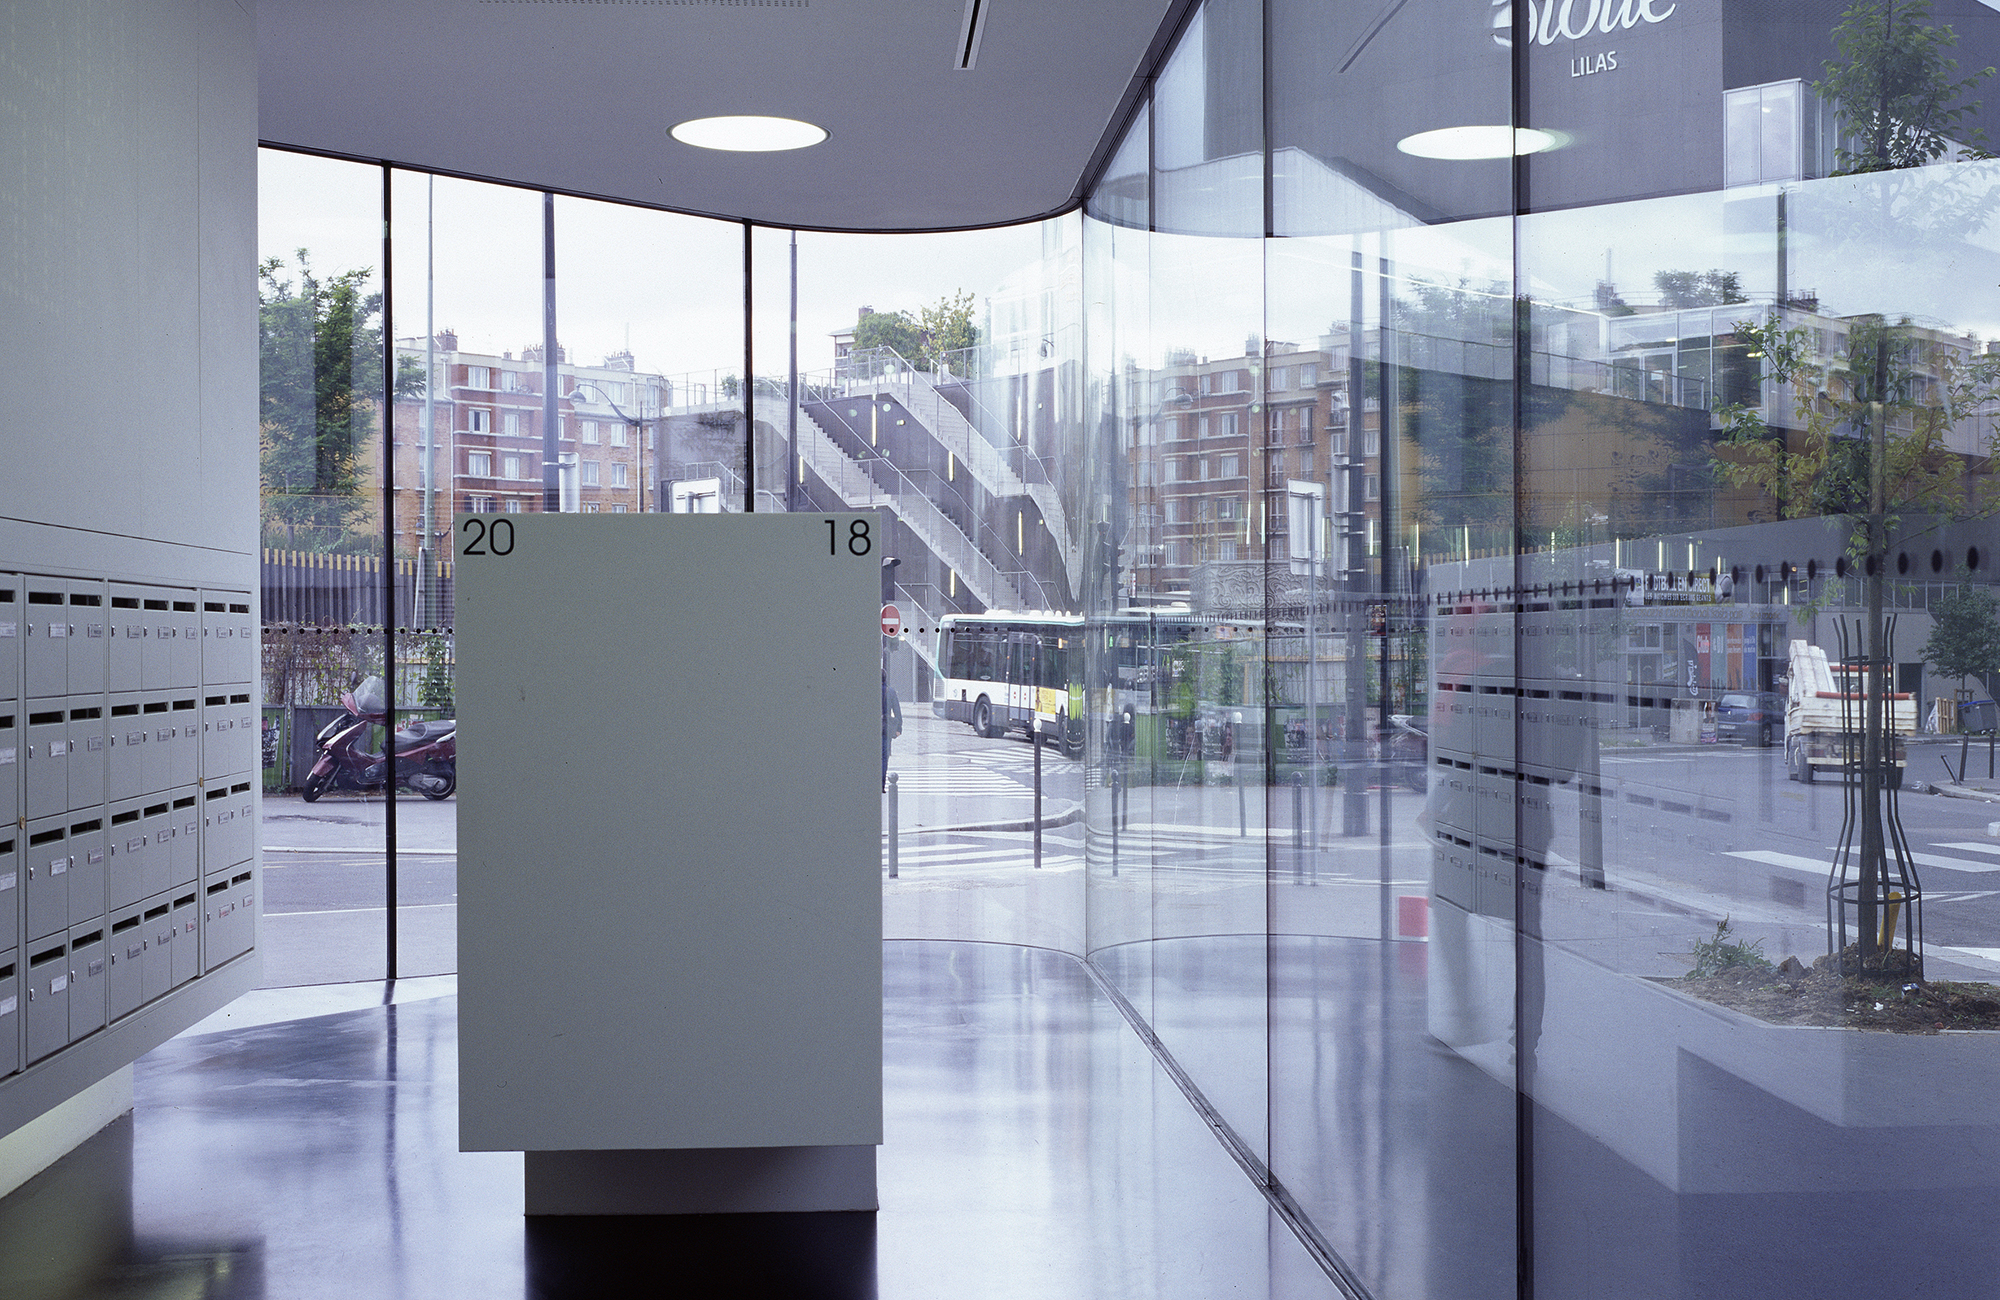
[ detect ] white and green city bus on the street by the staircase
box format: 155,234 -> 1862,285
930,610 -> 1084,754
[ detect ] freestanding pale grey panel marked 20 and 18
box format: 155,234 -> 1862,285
454,514 -> 882,1150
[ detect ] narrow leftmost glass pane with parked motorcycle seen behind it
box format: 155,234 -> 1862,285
254,150 -> 392,986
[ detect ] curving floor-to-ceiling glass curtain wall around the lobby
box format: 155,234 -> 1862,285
262,0 -> 2000,1272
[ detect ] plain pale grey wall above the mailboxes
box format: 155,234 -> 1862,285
0,0 -> 258,586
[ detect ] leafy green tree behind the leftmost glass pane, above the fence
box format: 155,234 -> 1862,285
258,248 -> 424,550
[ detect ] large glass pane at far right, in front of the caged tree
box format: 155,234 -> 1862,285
1512,4 -> 2000,1296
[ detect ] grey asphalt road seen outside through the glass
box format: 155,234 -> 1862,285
246,710 -> 2000,972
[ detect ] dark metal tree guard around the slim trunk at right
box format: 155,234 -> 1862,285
1826,616 -> 1924,980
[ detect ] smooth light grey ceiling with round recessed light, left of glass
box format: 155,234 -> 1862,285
258,0 -> 1182,230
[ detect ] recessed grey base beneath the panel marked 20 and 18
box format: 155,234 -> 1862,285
526,1146 -> 876,1214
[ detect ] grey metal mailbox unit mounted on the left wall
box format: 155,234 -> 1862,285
0,556 -> 258,1104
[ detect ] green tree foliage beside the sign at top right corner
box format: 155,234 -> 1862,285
1812,0 -> 1994,174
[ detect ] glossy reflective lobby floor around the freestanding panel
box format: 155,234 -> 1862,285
0,942 -> 1336,1300
